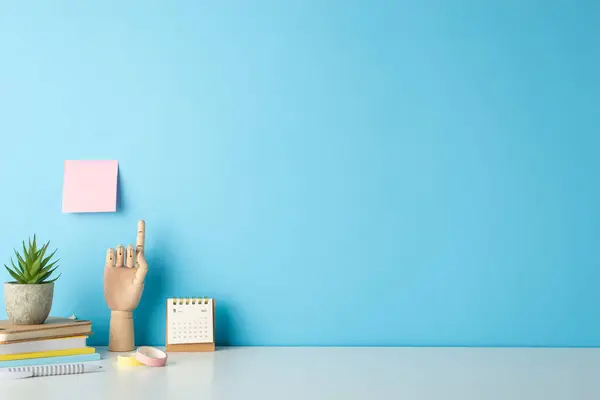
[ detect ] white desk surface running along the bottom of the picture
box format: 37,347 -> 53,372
0,347 -> 600,400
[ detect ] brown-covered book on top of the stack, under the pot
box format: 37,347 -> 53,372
0,317 -> 92,343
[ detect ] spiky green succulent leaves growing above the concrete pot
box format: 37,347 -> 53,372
4,235 -> 60,285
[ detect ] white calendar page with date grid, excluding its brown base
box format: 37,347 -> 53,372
167,299 -> 214,344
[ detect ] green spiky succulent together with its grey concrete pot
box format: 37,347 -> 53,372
4,235 -> 60,325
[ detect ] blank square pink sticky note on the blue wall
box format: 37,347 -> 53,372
63,160 -> 119,213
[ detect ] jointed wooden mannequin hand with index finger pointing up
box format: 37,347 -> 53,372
104,221 -> 148,351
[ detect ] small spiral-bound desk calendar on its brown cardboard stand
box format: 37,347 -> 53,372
166,297 -> 215,352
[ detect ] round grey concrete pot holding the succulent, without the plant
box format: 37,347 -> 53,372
4,282 -> 54,325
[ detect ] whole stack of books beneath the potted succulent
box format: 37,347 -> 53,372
0,317 -> 100,368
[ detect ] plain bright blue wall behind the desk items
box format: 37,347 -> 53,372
0,0 -> 600,346
